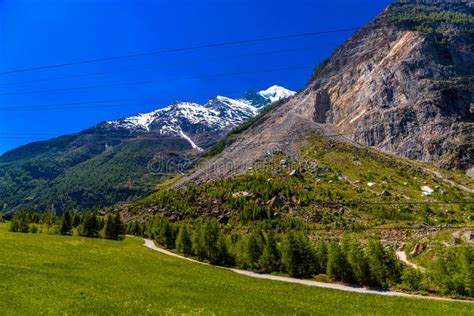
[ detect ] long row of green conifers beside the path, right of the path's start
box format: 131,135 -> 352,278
126,217 -> 403,288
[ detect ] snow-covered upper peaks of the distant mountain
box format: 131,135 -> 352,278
105,85 -> 295,151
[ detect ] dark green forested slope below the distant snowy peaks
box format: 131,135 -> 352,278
0,135 -> 197,213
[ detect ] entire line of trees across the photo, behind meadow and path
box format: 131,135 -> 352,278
10,211 -> 474,297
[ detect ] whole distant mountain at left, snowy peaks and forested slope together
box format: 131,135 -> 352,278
0,86 -> 293,212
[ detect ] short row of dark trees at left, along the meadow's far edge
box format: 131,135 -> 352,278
10,210 -> 125,240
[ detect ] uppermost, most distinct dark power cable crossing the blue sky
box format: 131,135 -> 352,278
0,27 -> 359,75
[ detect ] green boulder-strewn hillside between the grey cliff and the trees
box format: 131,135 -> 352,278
128,136 -> 474,230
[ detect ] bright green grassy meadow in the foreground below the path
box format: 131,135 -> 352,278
0,224 -> 474,315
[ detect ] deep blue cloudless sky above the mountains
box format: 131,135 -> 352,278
0,0 -> 390,153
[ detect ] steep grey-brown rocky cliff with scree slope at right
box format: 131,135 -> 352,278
185,1 -> 474,184
